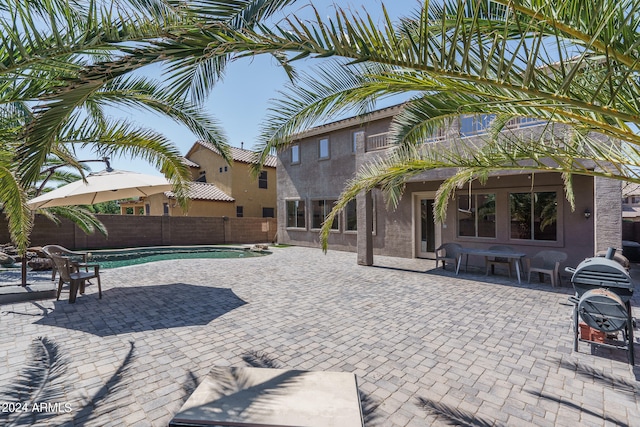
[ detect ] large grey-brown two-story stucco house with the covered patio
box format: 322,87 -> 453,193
277,106 -> 622,265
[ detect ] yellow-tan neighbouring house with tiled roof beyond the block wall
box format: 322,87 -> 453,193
142,141 -> 277,218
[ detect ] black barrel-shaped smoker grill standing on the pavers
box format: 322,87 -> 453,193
565,248 -> 634,365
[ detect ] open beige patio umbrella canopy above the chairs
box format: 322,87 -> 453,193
27,170 -> 172,210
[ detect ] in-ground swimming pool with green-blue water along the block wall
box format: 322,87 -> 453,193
82,246 -> 271,269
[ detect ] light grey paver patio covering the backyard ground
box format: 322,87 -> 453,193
0,247 -> 640,427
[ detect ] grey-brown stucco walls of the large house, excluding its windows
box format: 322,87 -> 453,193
278,109 -> 622,267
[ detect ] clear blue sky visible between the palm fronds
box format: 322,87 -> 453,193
99,0 -> 421,175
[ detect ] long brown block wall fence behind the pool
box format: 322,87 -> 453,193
0,215 -> 277,249
